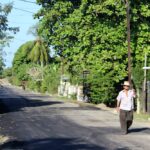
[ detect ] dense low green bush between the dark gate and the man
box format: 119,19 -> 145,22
88,74 -> 118,105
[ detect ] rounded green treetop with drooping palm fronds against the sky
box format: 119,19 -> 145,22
13,40 -> 49,69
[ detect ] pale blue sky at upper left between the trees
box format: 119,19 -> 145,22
0,0 -> 40,67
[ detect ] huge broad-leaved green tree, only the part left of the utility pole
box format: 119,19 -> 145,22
34,0 -> 127,102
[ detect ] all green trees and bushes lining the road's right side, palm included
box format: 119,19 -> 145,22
2,0 -> 150,105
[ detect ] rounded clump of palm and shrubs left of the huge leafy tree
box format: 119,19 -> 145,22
11,39 -> 60,93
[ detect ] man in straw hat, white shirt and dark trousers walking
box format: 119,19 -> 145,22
117,81 -> 135,134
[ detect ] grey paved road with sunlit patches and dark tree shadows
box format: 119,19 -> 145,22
0,86 -> 150,150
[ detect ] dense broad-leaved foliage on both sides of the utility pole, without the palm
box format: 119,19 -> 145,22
35,0 -> 150,103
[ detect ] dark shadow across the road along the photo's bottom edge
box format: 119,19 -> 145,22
0,138 -> 106,150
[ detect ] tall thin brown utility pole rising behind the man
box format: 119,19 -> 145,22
126,0 -> 132,85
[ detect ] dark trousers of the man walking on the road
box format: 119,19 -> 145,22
120,110 -> 133,133
